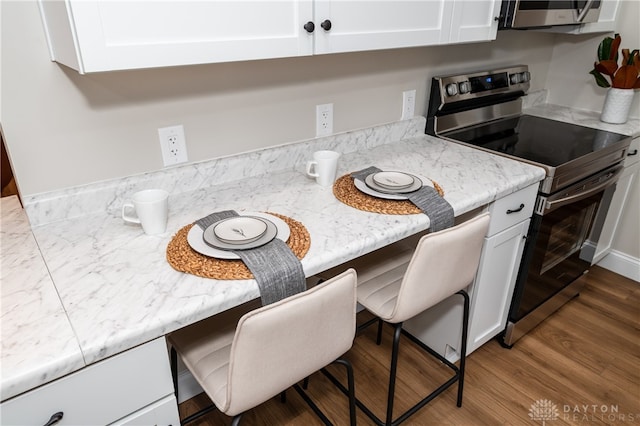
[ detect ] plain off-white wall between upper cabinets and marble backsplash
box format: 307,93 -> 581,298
0,0 -> 555,195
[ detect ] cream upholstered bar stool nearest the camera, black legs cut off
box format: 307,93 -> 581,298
168,270 -> 356,424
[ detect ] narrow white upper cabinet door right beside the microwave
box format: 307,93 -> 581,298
448,0 -> 502,43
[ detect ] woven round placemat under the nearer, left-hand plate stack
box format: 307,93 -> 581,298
167,212 -> 311,280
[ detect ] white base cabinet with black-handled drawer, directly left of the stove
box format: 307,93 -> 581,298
404,184 -> 538,361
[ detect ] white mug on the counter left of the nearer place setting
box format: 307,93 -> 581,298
122,189 -> 169,235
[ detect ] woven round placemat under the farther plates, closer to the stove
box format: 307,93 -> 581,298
333,174 -> 444,214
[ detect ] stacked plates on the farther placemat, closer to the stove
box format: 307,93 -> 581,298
354,171 -> 431,200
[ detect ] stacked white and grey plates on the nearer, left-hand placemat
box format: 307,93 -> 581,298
187,212 -> 290,259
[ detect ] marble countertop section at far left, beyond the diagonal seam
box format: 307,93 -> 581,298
0,195 -> 85,400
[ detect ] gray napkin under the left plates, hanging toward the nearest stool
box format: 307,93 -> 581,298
195,210 -> 307,305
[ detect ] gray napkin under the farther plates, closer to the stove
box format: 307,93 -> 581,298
351,166 -> 454,232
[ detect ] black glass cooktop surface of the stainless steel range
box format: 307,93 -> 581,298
442,115 -> 628,167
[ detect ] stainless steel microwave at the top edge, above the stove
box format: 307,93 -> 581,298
498,0 -> 602,29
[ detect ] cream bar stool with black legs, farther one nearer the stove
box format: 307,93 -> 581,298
329,213 -> 489,425
